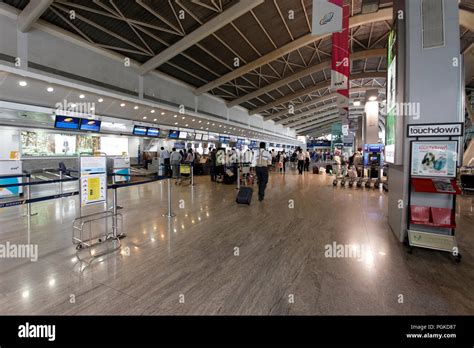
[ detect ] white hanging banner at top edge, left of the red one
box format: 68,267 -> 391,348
311,0 -> 343,35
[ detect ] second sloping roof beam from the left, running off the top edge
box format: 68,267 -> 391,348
138,0 -> 263,75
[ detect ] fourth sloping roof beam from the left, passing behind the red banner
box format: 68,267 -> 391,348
227,48 -> 387,107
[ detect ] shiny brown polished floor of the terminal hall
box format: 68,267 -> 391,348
0,169 -> 474,315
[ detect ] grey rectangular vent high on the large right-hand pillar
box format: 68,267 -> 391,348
421,0 -> 444,48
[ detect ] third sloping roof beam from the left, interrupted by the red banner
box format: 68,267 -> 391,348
195,7 -> 393,95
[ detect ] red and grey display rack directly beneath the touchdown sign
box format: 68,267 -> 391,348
407,137 -> 461,262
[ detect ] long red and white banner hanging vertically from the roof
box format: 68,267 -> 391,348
331,1 -> 350,124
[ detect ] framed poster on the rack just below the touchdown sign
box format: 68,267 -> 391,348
411,141 -> 457,177
